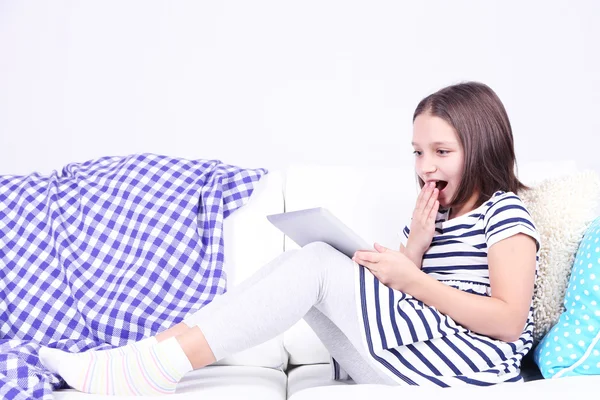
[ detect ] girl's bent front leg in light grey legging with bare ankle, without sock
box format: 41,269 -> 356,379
177,242 -> 360,369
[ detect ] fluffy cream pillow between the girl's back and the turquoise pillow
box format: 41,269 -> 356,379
519,171 -> 600,343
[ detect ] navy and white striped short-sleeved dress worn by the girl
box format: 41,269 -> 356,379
346,192 -> 540,387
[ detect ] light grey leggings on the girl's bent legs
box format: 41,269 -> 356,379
184,242 -> 396,385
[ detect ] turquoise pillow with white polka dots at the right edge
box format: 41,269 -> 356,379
533,217 -> 600,378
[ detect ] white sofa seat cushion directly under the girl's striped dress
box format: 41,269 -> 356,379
289,375 -> 600,400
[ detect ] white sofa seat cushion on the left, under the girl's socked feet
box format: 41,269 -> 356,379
54,366 -> 287,400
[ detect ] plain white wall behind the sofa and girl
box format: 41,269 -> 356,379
0,0 -> 600,173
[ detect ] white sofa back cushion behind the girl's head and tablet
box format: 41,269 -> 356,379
284,161 -> 577,250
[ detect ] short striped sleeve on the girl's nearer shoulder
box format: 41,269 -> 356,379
483,192 -> 540,251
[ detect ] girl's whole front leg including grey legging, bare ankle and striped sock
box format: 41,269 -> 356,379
40,243 -> 386,394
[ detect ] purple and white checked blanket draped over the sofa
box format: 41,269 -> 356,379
0,154 -> 267,400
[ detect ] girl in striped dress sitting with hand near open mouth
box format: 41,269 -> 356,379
40,82 -> 540,395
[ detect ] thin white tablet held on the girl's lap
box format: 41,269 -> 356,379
267,207 -> 373,258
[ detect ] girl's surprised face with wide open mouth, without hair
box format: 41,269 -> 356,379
412,113 -> 469,211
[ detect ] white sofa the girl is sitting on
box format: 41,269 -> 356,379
55,161 -> 600,400
